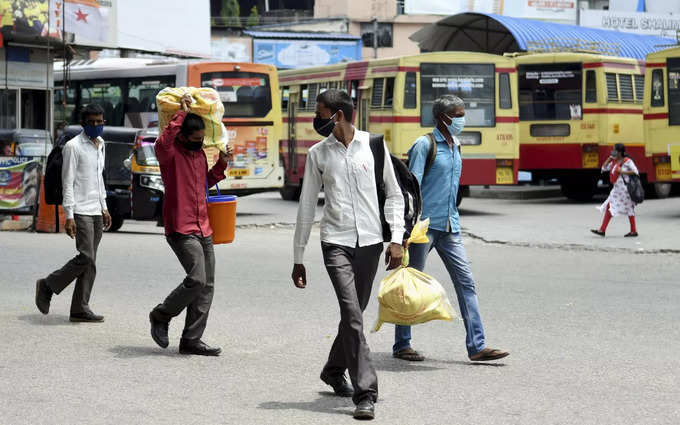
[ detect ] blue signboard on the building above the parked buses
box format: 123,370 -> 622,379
253,38 -> 361,69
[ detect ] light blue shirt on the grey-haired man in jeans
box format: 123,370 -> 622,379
408,128 -> 463,233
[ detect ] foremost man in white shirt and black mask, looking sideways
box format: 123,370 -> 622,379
292,90 -> 404,419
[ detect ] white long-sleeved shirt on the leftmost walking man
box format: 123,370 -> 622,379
61,133 -> 107,218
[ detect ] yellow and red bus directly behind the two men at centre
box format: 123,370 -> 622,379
279,52 -> 519,201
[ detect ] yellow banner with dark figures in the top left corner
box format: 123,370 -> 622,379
0,0 -> 49,36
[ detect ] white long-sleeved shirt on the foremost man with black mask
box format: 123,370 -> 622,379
293,129 -> 404,264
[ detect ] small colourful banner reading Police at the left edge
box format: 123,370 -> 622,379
0,156 -> 42,211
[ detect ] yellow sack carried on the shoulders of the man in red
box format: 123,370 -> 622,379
156,87 -> 228,152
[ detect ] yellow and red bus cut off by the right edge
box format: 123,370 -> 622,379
644,46 -> 680,197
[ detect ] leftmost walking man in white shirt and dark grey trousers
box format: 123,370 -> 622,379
35,104 -> 111,322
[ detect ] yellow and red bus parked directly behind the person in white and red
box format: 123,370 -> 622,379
509,52 -> 651,200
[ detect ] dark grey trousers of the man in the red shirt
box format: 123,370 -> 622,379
152,233 -> 215,340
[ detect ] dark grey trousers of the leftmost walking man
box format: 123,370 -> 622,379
45,214 -> 104,314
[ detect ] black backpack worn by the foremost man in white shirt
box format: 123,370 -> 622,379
370,134 -> 423,242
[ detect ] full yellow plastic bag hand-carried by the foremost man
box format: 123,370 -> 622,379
371,219 -> 456,332
